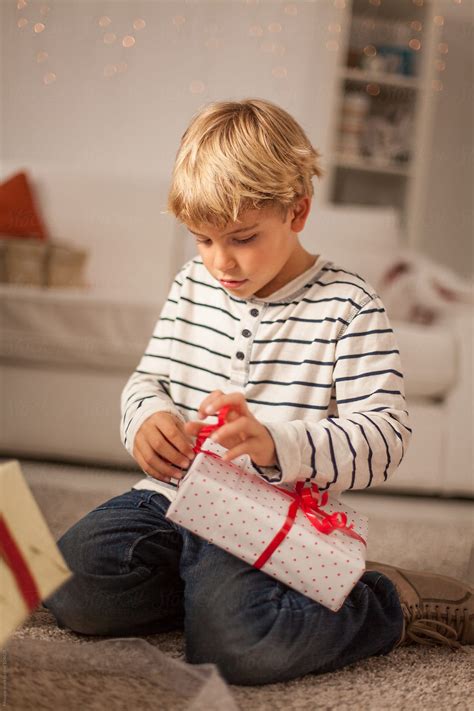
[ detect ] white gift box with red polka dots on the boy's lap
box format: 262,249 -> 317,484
166,442 -> 368,612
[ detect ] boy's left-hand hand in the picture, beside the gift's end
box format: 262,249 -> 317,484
133,412 -> 195,482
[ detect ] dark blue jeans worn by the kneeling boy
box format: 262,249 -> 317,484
45,489 -> 403,685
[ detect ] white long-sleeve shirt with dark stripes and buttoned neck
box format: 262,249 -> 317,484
120,256 -> 411,500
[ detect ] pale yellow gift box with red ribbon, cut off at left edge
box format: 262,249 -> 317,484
0,460 -> 72,647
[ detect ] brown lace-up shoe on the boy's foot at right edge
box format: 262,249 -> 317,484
366,561 -> 474,652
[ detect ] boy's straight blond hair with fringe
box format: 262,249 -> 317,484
167,99 -> 324,228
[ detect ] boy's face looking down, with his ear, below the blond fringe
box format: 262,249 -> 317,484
187,198 -> 314,299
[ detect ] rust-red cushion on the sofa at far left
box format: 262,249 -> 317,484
0,172 -> 48,240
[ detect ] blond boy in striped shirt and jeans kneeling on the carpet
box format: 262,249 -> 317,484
43,100 -> 473,684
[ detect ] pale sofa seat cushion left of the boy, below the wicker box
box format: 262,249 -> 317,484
0,285 -> 160,373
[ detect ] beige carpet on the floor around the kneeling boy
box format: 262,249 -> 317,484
1,462 -> 474,711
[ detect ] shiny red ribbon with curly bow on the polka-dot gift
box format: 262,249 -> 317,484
189,407 -> 367,568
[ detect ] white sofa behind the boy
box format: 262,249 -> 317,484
0,168 -> 474,496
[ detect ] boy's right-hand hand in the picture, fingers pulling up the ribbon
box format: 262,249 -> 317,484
184,390 -> 276,467
